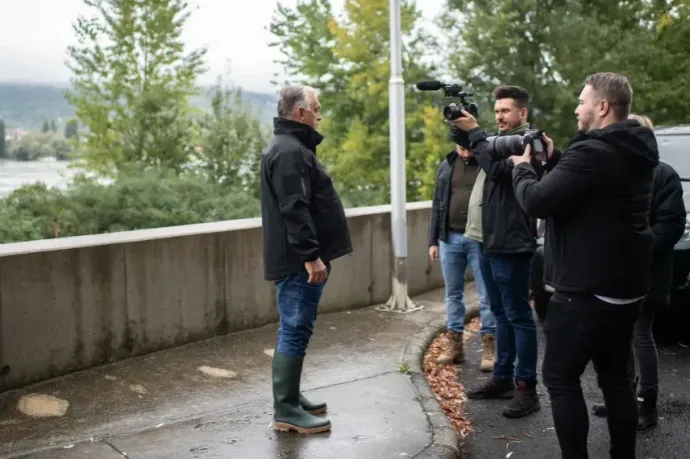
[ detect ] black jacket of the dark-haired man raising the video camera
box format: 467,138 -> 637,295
452,128 -> 543,254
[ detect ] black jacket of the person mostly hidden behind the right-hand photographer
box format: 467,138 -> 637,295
647,161 -> 686,303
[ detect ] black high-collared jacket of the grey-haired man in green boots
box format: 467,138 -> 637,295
261,118 -> 352,280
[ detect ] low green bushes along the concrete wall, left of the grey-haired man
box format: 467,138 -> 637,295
0,168 -> 259,243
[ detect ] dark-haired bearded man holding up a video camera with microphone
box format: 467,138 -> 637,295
450,86 -> 540,418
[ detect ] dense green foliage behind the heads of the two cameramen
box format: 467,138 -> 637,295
441,0 -> 690,145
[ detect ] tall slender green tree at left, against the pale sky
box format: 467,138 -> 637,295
67,0 -> 206,175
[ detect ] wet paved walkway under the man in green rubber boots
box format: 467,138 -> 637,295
0,291 -> 470,459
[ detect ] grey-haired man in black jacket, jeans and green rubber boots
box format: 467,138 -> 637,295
261,86 -> 352,433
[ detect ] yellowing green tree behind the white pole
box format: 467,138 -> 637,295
270,0 -> 452,206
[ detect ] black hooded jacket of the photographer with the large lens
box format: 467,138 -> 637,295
513,121 -> 659,299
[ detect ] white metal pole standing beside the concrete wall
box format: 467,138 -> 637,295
378,0 -> 421,312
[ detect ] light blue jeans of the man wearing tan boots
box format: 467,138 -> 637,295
439,232 -> 496,336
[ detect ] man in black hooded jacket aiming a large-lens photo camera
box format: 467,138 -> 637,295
511,73 -> 659,459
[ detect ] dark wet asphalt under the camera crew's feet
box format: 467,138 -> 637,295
461,328 -> 690,459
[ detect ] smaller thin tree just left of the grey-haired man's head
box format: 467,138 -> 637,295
196,74 -> 270,197
